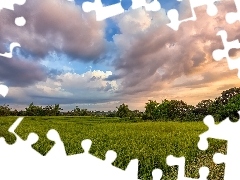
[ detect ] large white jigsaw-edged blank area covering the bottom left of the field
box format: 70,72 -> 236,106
0,117 -> 162,180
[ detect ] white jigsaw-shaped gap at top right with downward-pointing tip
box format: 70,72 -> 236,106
167,0 -> 221,31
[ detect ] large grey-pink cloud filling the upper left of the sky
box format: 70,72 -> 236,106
0,0 -> 107,61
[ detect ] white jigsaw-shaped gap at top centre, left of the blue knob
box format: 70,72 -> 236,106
82,0 -> 124,21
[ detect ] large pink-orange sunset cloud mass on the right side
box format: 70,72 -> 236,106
109,1 -> 240,97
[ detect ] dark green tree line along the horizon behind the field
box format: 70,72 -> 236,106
0,87 -> 240,121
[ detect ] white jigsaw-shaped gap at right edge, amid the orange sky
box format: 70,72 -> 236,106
212,30 -> 240,78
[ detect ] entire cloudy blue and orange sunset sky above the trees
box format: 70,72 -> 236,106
0,0 -> 240,111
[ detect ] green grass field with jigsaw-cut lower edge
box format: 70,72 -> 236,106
0,117 -> 226,180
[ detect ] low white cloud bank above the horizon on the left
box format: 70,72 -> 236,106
0,70 -> 118,105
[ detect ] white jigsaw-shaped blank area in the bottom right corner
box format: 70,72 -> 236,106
198,111 -> 240,180
